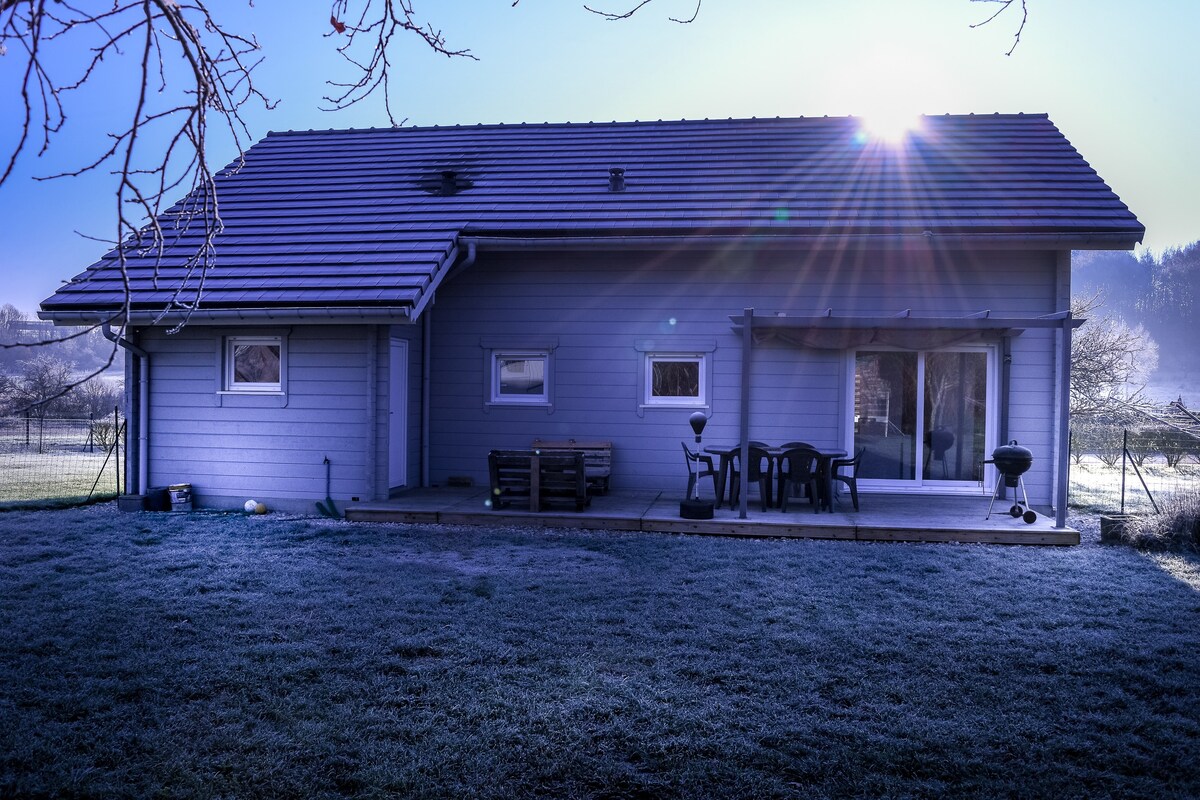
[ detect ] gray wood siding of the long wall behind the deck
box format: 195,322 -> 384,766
431,252 -> 1056,503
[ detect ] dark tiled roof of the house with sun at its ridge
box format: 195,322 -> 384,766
42,114 -> 1145,320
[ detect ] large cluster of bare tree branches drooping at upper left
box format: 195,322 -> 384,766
0,0 -> 274,331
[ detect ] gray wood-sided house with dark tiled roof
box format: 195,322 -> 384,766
41,114 -> 1144,525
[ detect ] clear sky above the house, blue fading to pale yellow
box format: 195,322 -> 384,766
0,0 -> 1200,311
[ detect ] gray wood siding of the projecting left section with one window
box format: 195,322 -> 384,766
140,325 -> 386,511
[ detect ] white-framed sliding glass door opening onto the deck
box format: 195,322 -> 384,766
852,348 -> 995,491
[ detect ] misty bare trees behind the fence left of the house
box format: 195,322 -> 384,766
0,303 -> 124,420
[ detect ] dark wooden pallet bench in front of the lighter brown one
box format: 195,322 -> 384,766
487,450 -> 592,511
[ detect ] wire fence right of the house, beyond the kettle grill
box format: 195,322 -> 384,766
1069,419 -> 1200,513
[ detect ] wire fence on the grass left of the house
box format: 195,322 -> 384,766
0,414 -> 125,509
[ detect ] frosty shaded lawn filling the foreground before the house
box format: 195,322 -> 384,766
0,507 -> 1200,798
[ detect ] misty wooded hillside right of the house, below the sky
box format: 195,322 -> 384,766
1072,241 -> 1200,371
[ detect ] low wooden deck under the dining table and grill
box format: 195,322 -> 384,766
346,488 -> 1079,545
